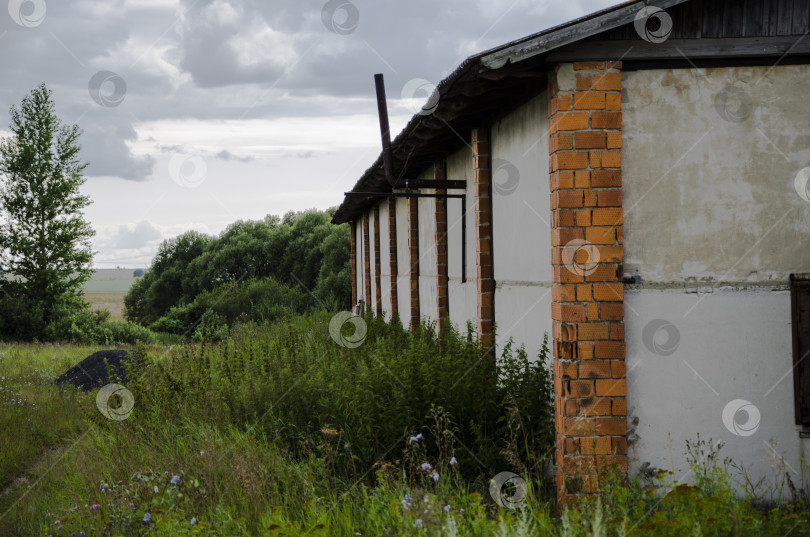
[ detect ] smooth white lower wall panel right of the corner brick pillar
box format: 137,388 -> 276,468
625,288 -> 810,493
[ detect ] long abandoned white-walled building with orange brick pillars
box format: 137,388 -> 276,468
334,0 -> 810,498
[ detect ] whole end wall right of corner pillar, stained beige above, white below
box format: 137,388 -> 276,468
622,66 -> 810,490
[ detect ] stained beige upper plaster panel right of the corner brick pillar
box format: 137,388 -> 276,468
622,65 -> 810,283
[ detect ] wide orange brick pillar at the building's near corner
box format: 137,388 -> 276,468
549,62 -> 627,502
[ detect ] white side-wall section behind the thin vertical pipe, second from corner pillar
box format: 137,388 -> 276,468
447,146 -> 478,332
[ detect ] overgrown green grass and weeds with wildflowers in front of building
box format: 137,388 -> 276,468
0,316 -> 810,537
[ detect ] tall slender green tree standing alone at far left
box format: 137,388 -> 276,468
0,84 -> 94,322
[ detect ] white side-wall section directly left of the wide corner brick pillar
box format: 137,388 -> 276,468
491,92 -> 551,357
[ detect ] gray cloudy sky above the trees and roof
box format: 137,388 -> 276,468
0,0 -> 616,267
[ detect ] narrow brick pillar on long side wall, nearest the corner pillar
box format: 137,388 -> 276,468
472,128 -> 495,347
